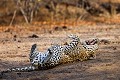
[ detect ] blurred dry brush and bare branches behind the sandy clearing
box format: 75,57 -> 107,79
0,0 -> 120,26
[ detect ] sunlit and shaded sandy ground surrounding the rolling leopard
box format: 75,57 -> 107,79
0,24 -> 120,80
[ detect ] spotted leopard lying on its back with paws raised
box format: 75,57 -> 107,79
0,35 -> 99,73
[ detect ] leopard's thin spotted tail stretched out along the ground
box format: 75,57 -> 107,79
1,66 -> 37,73
